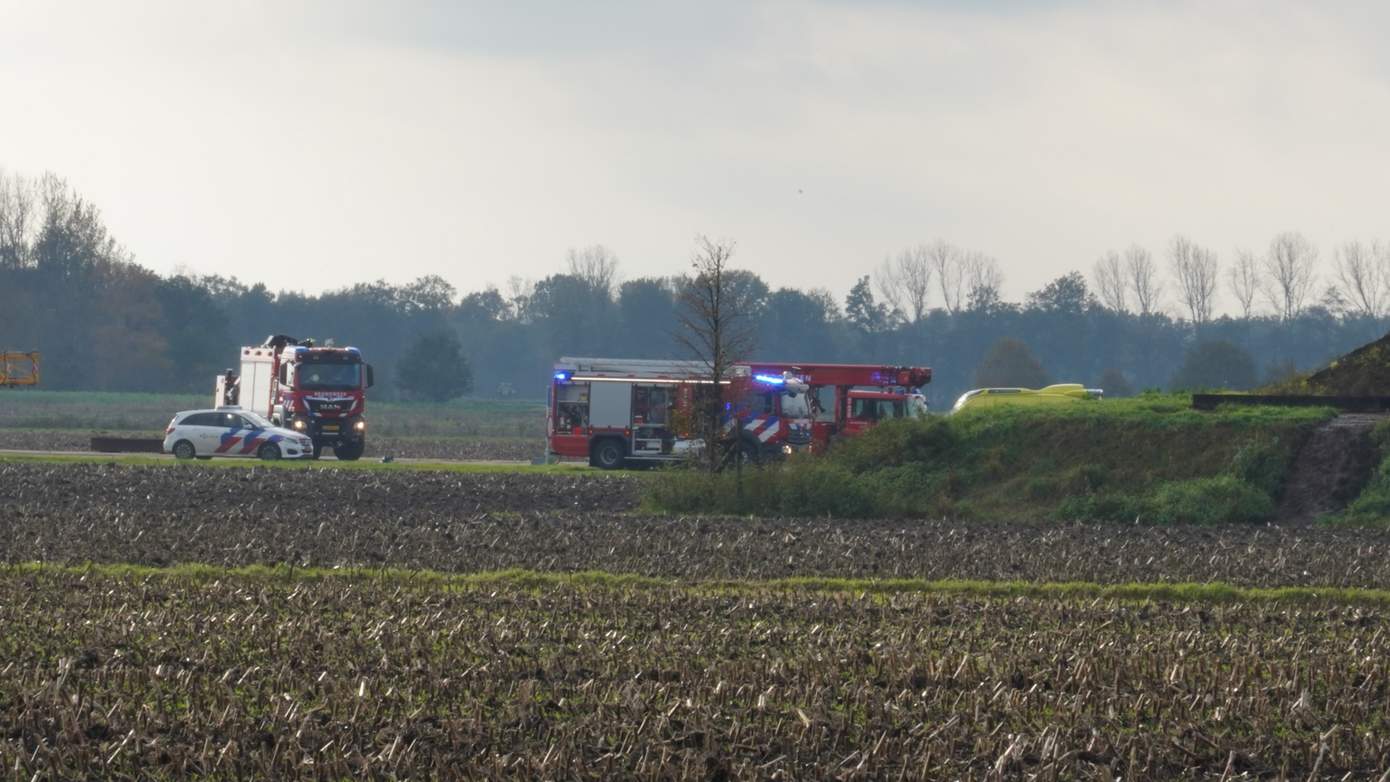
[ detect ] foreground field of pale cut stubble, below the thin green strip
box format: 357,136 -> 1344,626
0,569 -> 1390,779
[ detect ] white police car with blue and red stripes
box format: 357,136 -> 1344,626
164,407 -> 314,460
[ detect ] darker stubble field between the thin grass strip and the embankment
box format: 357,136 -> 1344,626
8,463 -> 1390,589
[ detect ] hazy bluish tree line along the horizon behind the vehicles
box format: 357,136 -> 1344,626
0,172 -> 1390,407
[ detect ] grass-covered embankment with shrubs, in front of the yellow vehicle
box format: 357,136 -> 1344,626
648,394 -> 1334,524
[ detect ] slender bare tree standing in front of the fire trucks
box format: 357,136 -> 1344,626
674,236 -> 753,471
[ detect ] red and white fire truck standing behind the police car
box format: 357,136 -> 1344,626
213,335 -> 374,461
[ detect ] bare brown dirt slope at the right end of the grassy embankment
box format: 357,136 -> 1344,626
1279,414 -> 1386,522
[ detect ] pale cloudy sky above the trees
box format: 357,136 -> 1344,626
0,0 -> 1390,301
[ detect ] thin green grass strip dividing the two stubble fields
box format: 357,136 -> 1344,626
0,563 -> 1390,607
